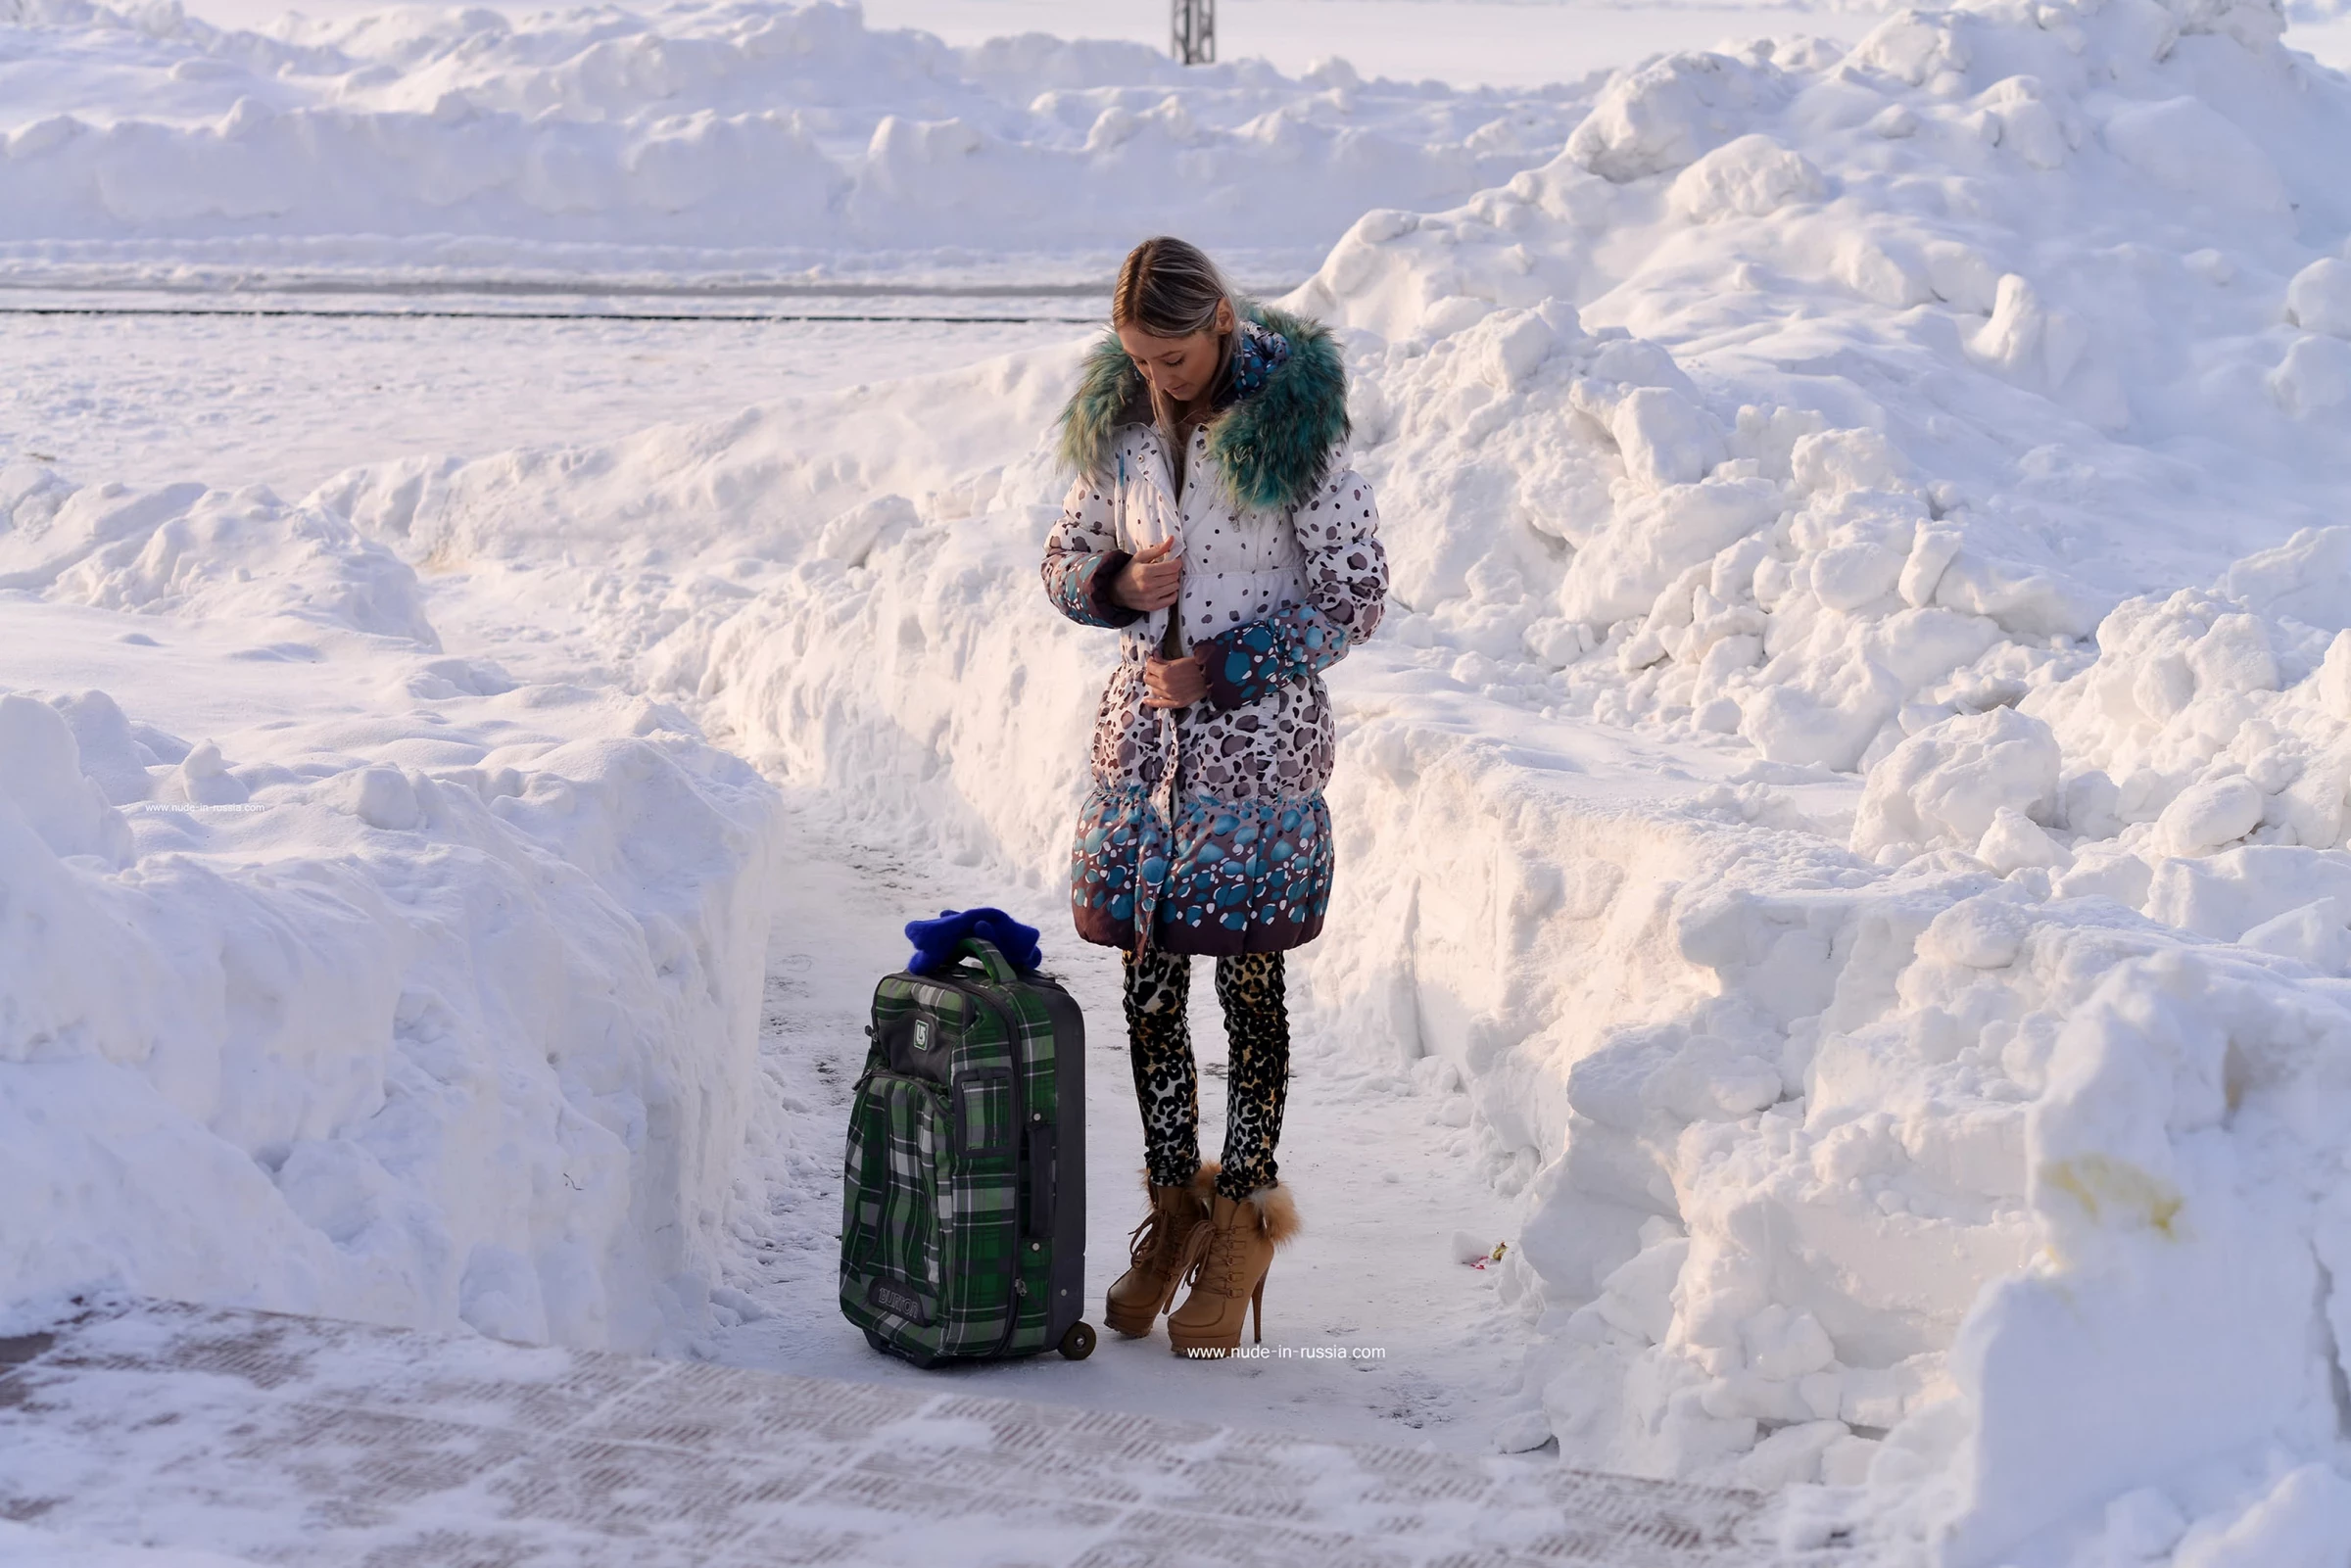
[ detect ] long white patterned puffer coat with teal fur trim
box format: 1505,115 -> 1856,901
1044,306 -> 1387,955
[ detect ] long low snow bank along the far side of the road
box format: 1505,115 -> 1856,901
0,0 -> 1582,277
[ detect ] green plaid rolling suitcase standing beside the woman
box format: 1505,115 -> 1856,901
841,938 -> 1093,1366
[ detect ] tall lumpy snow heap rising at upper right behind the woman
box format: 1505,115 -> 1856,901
1298,5 -> 2351,769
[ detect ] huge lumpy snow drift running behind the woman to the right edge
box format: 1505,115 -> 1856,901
294,0 -> 2351,1563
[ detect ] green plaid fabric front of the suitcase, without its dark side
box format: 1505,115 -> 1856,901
841,964 -> 1083,1363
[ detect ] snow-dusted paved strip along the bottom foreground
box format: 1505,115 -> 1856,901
0,1305 -> 1814,1568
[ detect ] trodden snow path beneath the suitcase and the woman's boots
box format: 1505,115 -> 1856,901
703,814 -> 1526,1450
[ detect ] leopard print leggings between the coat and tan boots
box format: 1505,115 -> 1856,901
1127,952 -> 1291,1199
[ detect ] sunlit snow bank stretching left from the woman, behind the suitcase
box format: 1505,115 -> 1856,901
311,343 -> 1107,870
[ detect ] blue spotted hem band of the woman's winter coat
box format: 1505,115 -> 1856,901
1070,785 -> 1330,955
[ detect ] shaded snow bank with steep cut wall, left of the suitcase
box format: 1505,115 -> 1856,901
0,468 -> 774,1347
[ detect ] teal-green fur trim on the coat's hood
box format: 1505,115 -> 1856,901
1060,301 -> 1347,510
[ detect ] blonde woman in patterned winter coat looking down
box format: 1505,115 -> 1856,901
1044,237 -> 1387,1354
